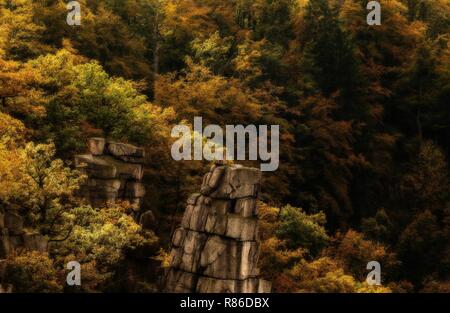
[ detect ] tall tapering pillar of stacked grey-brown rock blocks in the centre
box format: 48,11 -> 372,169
164,164 -> 271,293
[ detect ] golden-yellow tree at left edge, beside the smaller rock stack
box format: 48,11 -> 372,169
0,119 -> 82,237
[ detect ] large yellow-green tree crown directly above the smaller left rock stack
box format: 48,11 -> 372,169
27,47 -> 171,155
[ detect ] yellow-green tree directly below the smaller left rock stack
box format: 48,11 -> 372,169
50,203 -> 158,292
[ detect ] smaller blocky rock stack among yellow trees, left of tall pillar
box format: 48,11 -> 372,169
75,138 -> 145,211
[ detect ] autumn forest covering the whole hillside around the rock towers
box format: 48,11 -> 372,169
0,0 -> 450,292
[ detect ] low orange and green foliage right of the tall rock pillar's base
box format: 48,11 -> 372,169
258,203 -> 395,293
